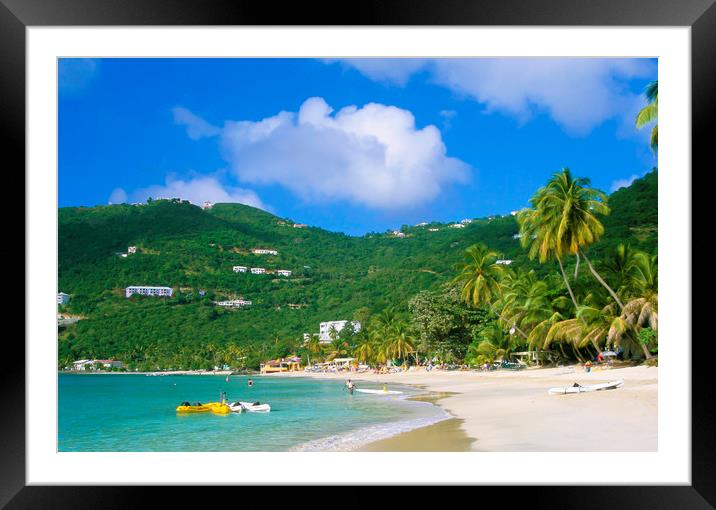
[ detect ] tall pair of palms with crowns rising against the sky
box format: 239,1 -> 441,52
518,168 -> 624,309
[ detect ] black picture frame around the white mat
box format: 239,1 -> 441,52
0,0 -> 716,509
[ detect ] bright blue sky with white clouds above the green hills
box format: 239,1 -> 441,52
58,58 -> 657,235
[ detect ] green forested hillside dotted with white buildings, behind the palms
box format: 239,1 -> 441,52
59,171 -> 657,368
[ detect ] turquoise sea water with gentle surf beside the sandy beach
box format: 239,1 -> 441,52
58,374 -> 448,452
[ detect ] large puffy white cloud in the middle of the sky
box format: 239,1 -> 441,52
210,97 -> 469,209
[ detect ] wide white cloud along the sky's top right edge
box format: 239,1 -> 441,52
330,58 -> 656,135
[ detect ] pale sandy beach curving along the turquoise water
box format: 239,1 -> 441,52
275,366 -> 658,452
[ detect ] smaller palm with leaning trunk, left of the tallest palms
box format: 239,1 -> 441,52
452,244 -> 527,339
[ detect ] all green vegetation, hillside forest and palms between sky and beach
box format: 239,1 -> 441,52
58,170 -> 657,369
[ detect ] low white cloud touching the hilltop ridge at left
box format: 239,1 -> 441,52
132,175 -> 269,210
